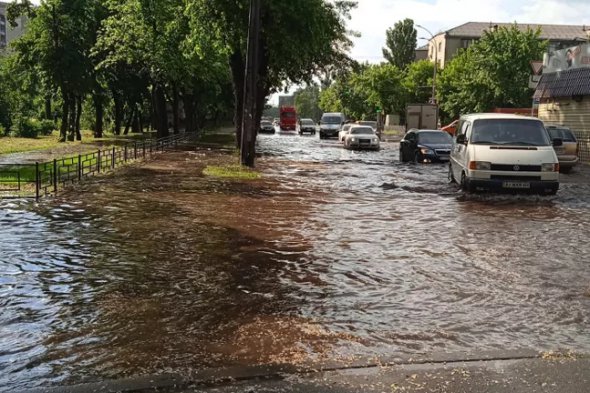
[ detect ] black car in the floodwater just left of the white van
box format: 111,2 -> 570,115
399,129 -> 453,163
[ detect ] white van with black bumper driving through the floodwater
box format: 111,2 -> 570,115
449,113 -> 563,194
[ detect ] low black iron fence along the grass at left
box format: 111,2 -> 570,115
0,134 -> 191,199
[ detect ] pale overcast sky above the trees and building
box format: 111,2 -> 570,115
349,0 -> 590,63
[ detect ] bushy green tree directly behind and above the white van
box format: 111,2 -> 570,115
437,25 -> 547,118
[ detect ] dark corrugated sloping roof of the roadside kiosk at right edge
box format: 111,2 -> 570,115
534,68 -> 590,99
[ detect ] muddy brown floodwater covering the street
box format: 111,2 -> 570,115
0,135 -> 590,391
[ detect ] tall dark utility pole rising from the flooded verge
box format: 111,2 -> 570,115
240,0 -> 261,167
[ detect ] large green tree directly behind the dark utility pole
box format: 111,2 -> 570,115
189,0 -> 356,148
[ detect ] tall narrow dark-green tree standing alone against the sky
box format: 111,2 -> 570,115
383,19 -> 417,70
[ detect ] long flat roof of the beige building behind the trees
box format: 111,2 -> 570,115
446,22 -> 586,41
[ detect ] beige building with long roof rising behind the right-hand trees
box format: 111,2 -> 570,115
428,22 -> 587,68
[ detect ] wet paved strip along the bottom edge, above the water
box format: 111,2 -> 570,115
26,351 -> 590,393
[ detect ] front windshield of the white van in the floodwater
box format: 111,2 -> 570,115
471,119 -> 550,146
